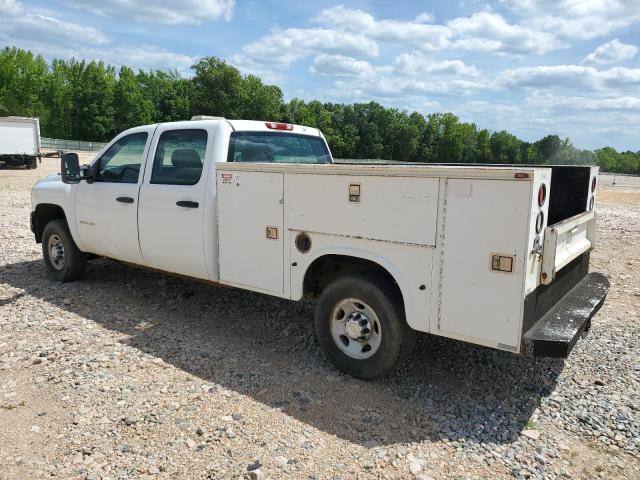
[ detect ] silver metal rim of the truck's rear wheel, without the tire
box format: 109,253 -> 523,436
331,298 -> 382,360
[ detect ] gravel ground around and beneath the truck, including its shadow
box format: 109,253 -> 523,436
0,160 -> 640,479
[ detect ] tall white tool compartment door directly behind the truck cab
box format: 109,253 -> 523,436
216,170 -> 284,294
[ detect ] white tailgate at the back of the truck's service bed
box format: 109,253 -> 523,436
540,211 -> 596,285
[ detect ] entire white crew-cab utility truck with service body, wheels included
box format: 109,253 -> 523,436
31,117 -> 609,379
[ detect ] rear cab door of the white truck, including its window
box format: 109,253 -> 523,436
138,125 -> 214,279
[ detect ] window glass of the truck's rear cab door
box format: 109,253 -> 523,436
151,129 -> 207,185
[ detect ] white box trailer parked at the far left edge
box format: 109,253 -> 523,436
0,117 -> 40,168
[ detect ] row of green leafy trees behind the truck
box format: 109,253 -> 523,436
0,47 -> 640,174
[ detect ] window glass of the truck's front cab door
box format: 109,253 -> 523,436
96,132 -> 148,183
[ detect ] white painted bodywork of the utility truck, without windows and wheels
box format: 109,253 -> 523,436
32,119 -> 606,378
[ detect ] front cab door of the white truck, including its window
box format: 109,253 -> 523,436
76,127 -> 153,265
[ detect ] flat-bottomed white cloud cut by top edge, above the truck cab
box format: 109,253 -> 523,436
66,0 -> 235,25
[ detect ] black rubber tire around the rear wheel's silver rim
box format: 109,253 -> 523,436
314,275 -> 415,380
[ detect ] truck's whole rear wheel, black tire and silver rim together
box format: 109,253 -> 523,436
315,275 -> 415,380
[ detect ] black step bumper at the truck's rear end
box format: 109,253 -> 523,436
522,272 -> 609,358
